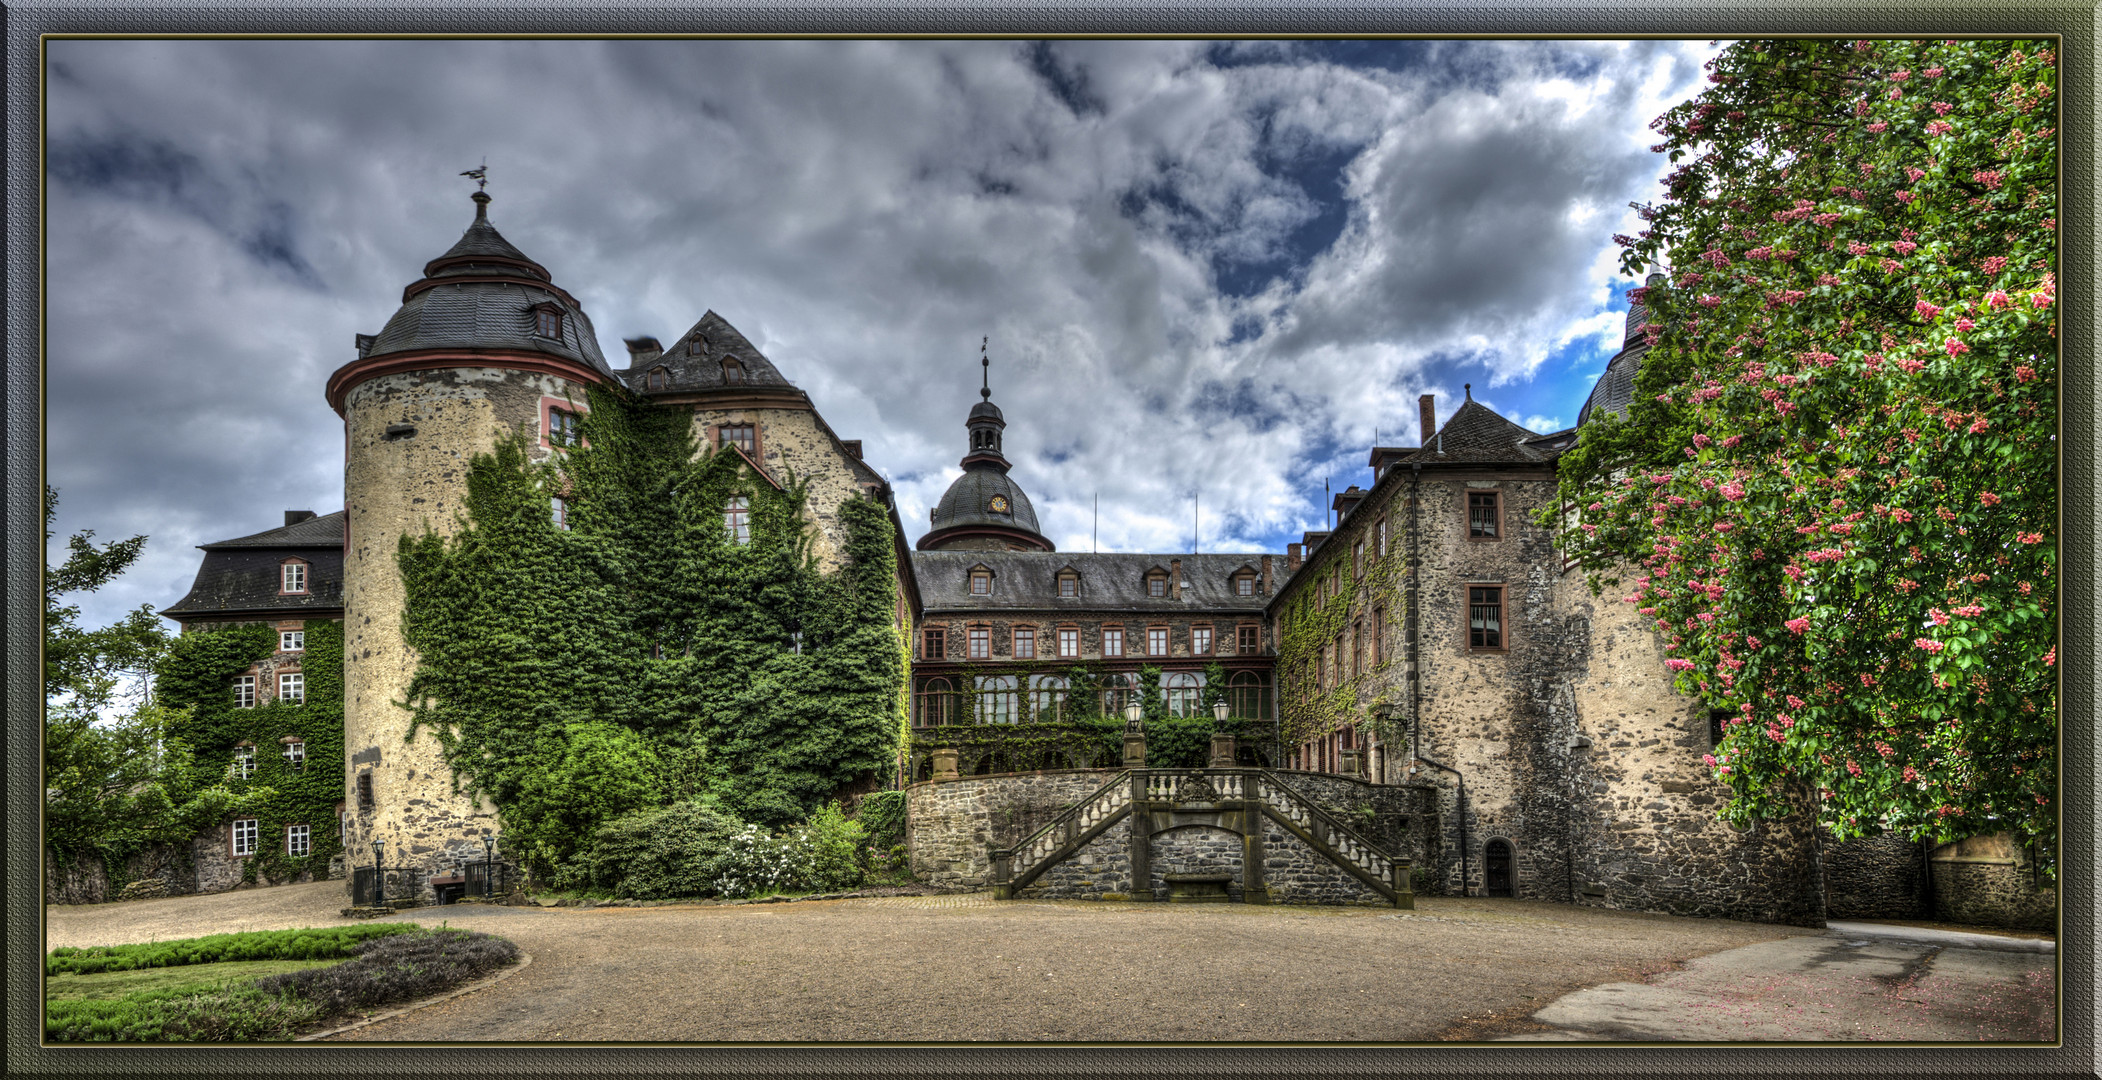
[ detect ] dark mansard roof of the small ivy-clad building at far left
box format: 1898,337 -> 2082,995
160,511 -> 345,622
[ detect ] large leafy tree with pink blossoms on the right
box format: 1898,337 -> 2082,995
1562,40 -> 2058,866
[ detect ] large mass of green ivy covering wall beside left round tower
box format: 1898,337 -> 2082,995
399,380 -> 906,870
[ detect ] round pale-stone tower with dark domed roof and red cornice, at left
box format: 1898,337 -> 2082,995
328,191 -> 614,890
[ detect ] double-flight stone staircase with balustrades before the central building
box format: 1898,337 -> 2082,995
992,769 -> 1415,908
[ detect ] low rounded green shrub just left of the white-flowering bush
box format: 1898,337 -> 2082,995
586,801 -> 744,899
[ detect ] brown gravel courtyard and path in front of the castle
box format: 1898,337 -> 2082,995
46,882 -> 1816,1042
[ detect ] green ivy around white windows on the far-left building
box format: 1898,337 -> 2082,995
153,620 -> 343,891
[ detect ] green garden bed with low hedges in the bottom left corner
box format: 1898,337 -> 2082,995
44,922 -> 519,1042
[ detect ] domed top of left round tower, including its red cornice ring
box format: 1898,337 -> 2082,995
328,191 -> 614,412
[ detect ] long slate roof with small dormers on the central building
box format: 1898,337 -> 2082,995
912,551 -> 1289,616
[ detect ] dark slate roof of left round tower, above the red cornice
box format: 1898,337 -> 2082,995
364,191 -> 612,376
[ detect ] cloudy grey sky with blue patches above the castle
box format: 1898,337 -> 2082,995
46,40 -> 1713,624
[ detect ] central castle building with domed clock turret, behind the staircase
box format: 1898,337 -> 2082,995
908,357 -> 1286,780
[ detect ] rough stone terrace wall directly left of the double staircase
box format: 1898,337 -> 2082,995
906,769 -> 1116,887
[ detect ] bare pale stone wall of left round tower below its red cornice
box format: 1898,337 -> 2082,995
343,368 -> 567,886
